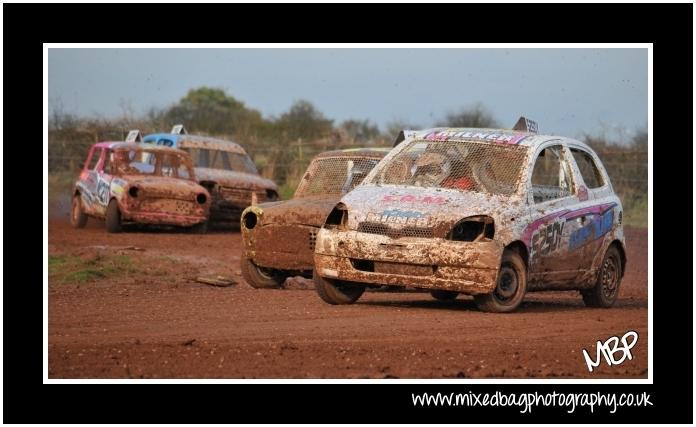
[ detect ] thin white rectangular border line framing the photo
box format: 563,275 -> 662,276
43,43 -> 652,384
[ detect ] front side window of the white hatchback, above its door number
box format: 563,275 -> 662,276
532,145 -> 574,203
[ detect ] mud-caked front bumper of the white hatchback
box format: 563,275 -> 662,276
314,229 -> 503,295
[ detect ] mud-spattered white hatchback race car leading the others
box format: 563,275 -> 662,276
314,118 -> 626,312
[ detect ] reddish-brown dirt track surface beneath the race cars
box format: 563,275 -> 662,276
48,213 -> 649,378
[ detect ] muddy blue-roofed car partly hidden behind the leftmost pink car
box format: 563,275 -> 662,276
143,125 -> 279,225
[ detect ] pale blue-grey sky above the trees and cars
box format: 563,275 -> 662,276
48,48 -> 648,138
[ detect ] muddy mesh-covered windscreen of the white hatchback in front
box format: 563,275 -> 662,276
370,140 -> 528,195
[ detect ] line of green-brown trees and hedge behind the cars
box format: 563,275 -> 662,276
48,87 -> 648,227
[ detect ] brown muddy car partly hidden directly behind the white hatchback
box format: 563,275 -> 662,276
241,148 -> 390,288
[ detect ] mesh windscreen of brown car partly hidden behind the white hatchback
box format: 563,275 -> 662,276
295,157 -> 379,198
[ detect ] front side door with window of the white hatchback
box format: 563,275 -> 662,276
525,143 -> 581,289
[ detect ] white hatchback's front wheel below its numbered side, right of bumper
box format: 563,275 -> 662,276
474,249 -> 527,313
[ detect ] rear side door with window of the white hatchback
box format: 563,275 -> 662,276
568,145 -> 616,270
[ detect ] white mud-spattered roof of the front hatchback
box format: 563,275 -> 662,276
409,127 -> 590,149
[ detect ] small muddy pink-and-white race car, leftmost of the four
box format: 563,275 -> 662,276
70,142 -> 210,233
